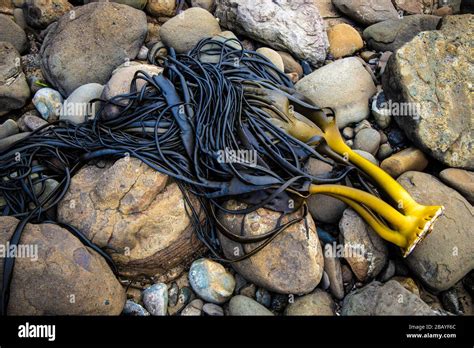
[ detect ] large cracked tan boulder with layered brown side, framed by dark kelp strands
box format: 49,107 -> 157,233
58,157 -> 203,277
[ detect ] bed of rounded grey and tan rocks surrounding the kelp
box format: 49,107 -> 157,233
0,0 -> 474,316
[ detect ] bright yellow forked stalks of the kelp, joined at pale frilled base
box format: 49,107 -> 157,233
284,95 -> 444,257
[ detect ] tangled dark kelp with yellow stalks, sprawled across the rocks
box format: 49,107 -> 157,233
0,39 -> 439,314
